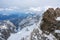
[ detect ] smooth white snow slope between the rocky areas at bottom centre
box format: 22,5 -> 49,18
8,24 -> 36,40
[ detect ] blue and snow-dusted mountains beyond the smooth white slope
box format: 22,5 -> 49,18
0,9 -> 41,40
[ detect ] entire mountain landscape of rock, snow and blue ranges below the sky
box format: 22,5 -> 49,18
0,8 -> 60,40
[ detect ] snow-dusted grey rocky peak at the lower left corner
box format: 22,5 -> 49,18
0,20 -> 16,40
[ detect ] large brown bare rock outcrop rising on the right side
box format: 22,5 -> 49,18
41,8 -> 60,40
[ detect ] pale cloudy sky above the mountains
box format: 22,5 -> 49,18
0,0 -> 60,11
